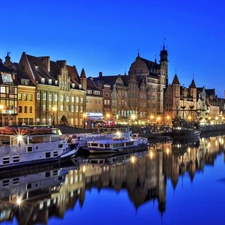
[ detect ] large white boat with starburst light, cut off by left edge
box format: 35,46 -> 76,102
0,126 -> 79,171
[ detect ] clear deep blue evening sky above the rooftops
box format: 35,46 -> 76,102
0,0 -> 225,97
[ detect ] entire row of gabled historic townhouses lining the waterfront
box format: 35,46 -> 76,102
0,45 -> 224,127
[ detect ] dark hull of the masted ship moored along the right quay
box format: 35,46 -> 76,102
172,117 -> 201,139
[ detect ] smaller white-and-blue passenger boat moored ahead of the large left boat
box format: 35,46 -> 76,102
82,132 -> 148,154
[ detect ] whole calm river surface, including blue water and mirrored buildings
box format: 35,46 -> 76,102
0,136 -> 225,225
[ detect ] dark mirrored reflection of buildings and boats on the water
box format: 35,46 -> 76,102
0,136 -> 225,225
